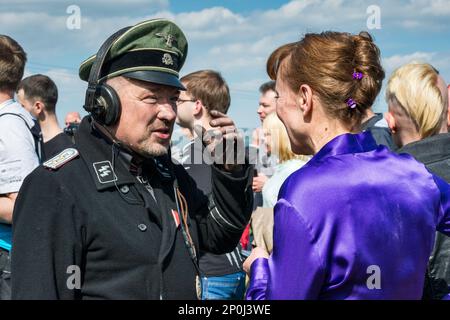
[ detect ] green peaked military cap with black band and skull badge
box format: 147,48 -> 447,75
79,19 -> 188,90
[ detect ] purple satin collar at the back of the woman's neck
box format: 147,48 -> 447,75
313,131 -> 378,161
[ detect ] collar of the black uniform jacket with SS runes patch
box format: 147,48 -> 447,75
75,116 -> 184,263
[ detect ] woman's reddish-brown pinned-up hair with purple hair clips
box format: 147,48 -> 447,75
267,31 -> 384,128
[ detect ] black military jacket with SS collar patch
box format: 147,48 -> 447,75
11,118 -> 252,299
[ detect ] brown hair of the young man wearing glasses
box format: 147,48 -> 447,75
180,70 -> 231,113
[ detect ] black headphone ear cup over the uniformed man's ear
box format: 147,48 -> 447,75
93,84 -> 121,126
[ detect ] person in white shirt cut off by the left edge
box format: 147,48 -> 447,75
0,35 -> 39,299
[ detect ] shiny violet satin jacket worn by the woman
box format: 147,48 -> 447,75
247,132 -> 450,300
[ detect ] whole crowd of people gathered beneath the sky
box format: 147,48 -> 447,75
0,19 -> 450,300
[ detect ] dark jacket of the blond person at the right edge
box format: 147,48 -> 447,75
397,133 -> 450,299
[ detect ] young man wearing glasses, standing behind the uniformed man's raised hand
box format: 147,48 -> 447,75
176,70 -> 245,300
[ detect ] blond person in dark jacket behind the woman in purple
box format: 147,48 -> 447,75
386,63 -> 450,299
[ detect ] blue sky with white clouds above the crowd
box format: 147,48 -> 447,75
0,0 -> 450,132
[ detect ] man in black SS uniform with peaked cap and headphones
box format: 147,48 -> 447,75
12,19 -> 252,299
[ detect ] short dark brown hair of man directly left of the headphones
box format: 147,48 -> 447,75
17,74 -> 58,113
